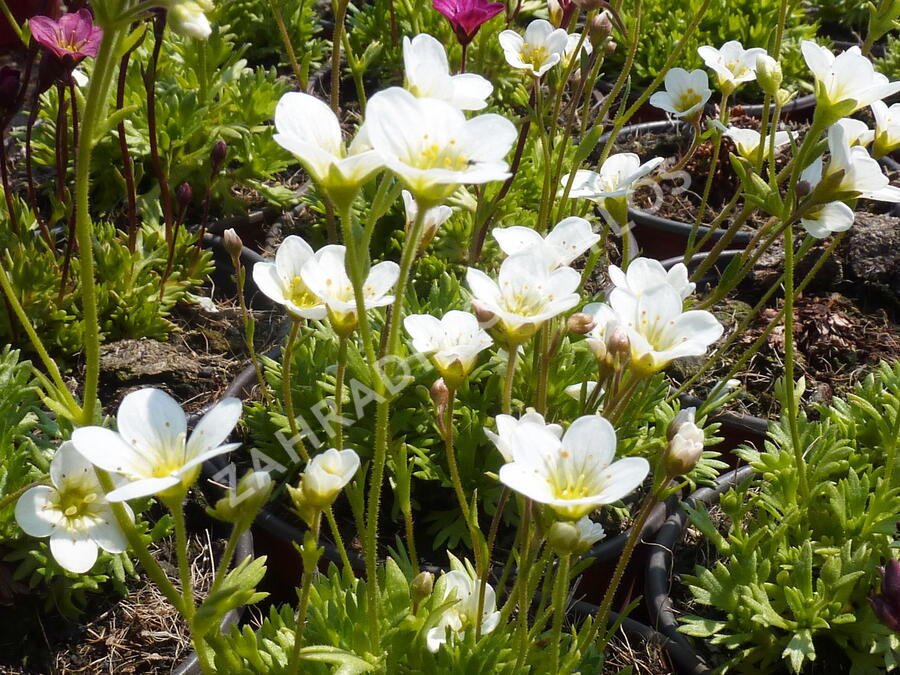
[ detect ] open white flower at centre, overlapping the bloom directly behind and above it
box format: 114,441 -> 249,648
466,250 -> 581,345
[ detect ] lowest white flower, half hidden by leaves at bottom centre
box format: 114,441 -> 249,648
425,553 -> 500,652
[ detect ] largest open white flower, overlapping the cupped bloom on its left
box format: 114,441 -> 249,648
365,87 -> 518,208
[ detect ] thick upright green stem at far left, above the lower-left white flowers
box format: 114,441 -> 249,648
75,26 -> 127,426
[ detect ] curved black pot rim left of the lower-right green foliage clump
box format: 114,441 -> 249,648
644,466 -> 753,675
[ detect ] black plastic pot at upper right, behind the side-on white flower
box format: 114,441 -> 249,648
600,120 -> 753,260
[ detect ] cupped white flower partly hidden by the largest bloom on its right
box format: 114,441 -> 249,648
273,92 -> 383,202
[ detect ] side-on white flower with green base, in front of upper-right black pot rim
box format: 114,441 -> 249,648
560,152 -> 664,224
